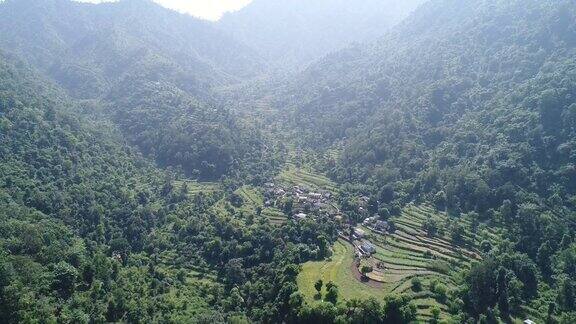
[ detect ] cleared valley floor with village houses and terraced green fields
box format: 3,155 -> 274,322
171,163 -> 501,322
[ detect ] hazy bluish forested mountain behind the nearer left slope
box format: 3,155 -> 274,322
0,0 -> 272,179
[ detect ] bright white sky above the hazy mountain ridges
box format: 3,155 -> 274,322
77,0 -> 252,20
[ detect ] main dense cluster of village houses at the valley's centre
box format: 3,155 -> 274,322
264,182 -> 342,220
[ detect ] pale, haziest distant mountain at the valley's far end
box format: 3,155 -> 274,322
217,0 -> 424,70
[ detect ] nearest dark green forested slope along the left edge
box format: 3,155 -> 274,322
0,51 -> 200,323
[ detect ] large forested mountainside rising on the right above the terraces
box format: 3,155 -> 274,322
289,0 -> 576,212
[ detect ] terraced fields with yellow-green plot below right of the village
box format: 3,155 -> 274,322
298,205 -> 498,321
